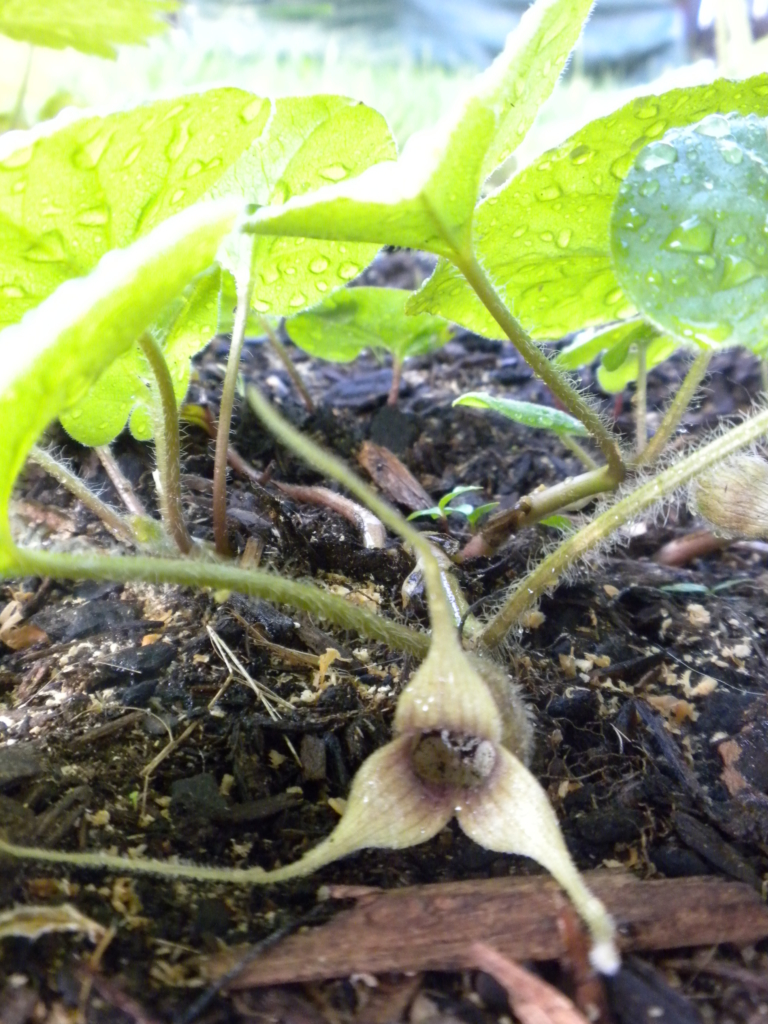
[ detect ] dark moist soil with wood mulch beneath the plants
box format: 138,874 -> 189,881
0,253 -> 768,1024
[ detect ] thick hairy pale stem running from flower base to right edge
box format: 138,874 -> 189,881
479,411 -> 768,647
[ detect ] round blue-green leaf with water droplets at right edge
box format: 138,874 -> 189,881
611,115 -> 768,354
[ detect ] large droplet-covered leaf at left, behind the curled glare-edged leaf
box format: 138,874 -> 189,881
0,89 -> 270,444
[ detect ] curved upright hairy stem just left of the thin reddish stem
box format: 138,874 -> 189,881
138,331 -> 193,555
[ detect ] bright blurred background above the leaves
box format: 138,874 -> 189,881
0,0 -> 768,165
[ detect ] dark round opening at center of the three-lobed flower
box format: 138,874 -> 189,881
411,729 -> 496,790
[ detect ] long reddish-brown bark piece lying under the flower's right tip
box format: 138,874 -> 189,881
202,871 -> 768,988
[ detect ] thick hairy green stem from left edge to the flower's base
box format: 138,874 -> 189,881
4,548 -> 429,657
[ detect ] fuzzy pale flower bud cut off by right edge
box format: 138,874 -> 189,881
691,455 -> 768,541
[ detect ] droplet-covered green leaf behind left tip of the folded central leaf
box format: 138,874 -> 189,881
215,96 -> 396,316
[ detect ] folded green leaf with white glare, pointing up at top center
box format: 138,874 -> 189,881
243,0 -> 592,258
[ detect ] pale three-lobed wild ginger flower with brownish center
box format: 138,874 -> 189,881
260,635 -> 618,974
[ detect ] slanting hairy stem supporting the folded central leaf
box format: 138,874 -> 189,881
454,255 -> 626,483
